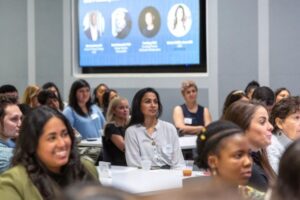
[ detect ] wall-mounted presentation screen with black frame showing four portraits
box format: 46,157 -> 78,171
77,0 -> 206,73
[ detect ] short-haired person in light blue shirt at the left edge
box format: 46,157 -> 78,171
0,96 -> 22,174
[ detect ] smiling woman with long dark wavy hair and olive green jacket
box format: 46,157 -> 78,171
0,106 -> 98,199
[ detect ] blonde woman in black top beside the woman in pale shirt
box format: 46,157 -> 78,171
102,97 -> 129,166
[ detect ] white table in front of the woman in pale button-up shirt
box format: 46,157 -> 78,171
98,166 -> 203,195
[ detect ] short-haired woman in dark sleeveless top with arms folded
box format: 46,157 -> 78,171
173,81 -> 211,134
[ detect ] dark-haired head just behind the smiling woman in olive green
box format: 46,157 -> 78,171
37,90 -> 60,111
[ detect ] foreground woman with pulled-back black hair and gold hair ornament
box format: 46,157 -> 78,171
196,121 -> 263,198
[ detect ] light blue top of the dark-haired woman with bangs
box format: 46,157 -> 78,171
63,105 -> 105,139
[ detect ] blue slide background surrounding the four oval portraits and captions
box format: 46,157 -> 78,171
78,0 -> 201,67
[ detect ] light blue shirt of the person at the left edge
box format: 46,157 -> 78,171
0,140 -> 14,174
